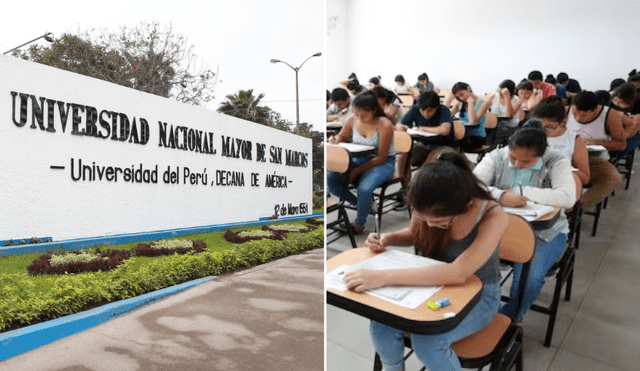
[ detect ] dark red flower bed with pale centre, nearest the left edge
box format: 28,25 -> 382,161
27,248 -> 131,275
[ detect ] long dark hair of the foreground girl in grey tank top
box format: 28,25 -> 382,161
409,149 -> 493,258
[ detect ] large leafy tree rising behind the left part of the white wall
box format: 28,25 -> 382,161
14,22 -> 217,106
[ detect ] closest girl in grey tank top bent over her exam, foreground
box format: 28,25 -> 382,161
345,152 -> 508,371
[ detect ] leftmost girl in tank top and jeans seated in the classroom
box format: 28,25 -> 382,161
327,91 -> 396,234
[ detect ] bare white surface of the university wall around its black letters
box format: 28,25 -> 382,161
0,56 -> 312,240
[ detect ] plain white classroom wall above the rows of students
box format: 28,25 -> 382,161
327,0 -> 640,92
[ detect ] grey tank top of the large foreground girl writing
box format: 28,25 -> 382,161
441,200 -> 500,285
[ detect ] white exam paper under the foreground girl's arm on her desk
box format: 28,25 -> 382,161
325,250 -> 444,309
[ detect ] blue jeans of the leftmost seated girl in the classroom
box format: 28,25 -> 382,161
327,156 -> 396,227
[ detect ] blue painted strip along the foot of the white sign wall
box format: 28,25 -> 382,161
0,213 -> 324,256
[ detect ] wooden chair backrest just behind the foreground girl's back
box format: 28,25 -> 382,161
500,214 -> 536,263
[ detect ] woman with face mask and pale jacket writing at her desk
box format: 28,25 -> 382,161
473,124 -> 576,320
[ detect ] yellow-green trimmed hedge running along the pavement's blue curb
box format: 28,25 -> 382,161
0,227 -> 324,332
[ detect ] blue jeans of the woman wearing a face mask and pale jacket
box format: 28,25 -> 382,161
500,233 -> 567,321
